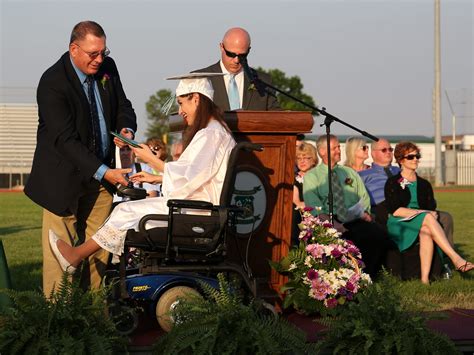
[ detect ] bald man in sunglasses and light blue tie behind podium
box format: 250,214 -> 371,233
196,27 -> 279,111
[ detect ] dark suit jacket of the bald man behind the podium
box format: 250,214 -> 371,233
195,61 -> 280,111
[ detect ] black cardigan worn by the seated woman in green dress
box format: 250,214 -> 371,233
385,174 -> 436,214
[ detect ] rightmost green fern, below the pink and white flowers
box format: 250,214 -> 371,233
317,274 -> 458,354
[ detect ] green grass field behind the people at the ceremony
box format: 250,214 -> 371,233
0,188 -> 474,309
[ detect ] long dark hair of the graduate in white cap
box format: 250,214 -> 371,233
180,93 -> 231,150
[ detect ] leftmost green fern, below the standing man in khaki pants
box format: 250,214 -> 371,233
0,274 -> 126,354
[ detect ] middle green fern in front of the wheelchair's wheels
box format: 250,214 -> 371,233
154,274 -> 314,355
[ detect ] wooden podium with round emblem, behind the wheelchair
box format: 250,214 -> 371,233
170,111 -> 313,292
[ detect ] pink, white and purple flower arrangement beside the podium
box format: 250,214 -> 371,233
270,207 -> 372,315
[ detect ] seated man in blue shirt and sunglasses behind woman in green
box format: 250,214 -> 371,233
359,138 -> 454,246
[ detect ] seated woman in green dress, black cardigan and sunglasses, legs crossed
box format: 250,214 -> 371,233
385,142 -> 474,283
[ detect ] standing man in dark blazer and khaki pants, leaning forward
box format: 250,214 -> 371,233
25,21 -> 137,296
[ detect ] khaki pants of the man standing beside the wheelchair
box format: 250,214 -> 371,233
42,186 -> 112,297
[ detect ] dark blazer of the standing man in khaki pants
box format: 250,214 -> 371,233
25,52 -> 137,215
